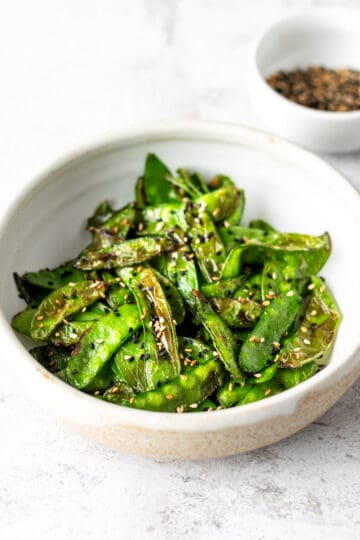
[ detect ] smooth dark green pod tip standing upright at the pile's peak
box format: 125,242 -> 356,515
143,154 -> 180,206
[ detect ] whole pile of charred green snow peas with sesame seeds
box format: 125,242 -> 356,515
12,154 -> 341,413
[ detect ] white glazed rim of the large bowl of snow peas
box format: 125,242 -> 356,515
0,121 -> 360,432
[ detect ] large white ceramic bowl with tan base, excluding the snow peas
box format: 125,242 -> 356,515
0,123 -> 360,458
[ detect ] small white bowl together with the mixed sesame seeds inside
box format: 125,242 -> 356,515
249,8 -> 360,153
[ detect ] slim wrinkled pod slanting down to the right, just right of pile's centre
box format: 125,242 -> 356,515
194,291 -> 241,377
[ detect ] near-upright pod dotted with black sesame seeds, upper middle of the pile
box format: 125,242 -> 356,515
185,205 -> 226,282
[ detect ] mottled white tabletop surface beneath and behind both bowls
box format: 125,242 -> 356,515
0,0 -> 360,540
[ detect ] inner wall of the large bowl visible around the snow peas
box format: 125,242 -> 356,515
0,130 -> 360,374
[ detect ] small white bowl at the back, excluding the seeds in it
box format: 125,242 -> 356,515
249,8 -> 360,153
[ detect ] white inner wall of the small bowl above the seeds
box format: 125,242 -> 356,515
256,9 -> 360,78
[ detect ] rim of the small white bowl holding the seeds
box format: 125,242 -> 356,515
249,7 -> 360,121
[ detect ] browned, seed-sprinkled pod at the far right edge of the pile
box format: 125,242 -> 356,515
279,276 -> 341,368
